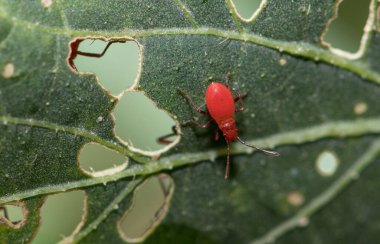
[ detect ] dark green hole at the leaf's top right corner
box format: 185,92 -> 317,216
323,0 -> 370,52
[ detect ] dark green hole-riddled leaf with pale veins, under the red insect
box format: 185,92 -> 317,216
0,0 -> 380,243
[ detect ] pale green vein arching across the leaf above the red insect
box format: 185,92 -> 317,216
0,6 -> 380,84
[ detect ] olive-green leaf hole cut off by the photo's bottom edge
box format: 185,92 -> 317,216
33,191 -> 87,243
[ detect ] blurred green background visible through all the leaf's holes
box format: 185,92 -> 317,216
0,0 -> 369,244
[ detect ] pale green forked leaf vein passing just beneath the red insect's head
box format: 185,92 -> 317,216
0,116 -> 380,204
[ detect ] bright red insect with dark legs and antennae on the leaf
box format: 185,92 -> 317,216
159,82 -> 280,179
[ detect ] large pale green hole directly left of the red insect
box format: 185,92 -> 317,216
114,92 -> 176,151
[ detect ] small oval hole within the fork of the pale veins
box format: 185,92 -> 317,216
78,143 -> 128,177
